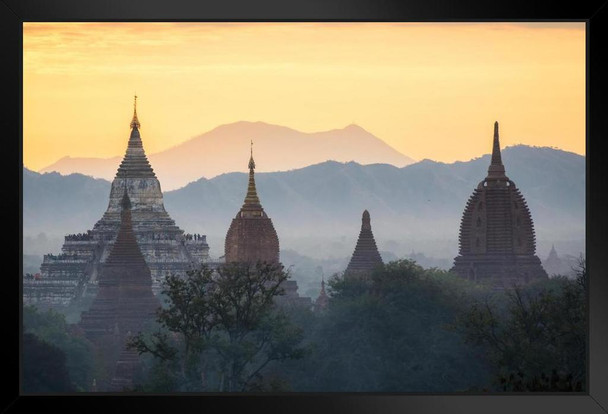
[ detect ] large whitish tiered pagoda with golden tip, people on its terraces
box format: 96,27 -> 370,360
23,96 -> 209,306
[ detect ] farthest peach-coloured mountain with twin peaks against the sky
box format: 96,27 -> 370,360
40,121 -> 414,191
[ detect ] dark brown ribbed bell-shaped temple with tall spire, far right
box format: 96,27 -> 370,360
451,122 -> 547,288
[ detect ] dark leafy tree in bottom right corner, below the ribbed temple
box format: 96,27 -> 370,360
455,260 -> 587,391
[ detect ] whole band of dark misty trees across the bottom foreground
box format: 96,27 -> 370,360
24,260 -> 588,393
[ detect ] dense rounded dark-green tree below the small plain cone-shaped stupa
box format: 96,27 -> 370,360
282,260 -> 488,392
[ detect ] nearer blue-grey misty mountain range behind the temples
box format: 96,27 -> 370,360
23,145 -> 585,257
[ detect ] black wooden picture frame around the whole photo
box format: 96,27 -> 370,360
0,0 -> 608,414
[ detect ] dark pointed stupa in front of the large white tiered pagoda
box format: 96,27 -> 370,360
80,189 -> 161,391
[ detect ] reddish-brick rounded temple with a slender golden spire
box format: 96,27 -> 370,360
224,142 -> 279,263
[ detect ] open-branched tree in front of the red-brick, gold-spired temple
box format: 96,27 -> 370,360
130,263 -> 304,391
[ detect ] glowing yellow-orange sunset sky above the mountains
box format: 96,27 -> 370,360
23,23 -> 585,170
